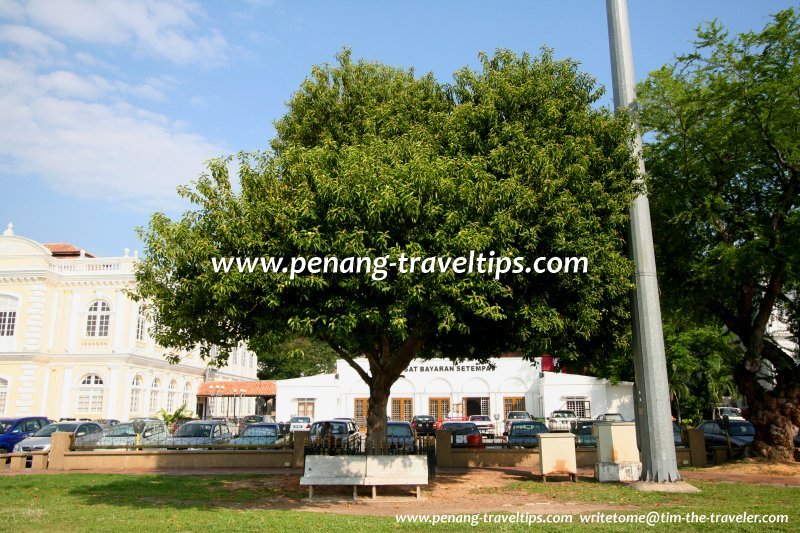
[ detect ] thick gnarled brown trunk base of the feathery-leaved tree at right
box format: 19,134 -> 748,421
736,368 -> 800,461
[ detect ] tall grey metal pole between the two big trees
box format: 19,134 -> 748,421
606,0 -> 680,483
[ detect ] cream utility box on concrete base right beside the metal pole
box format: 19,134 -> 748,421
592,421 -> 642,482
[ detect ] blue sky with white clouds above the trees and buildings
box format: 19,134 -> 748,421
0,0 -> 797,256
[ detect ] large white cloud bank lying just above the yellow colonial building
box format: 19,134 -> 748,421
0,59 -> 227,209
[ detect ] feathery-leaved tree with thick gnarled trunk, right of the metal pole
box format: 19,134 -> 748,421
638,9 -> 800,460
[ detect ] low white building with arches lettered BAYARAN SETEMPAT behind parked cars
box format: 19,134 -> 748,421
276,357 -> 634,424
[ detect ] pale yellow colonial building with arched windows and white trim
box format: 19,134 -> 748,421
0,224 -> 257,420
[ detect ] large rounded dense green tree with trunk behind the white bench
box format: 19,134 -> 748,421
136,51 -> 635,440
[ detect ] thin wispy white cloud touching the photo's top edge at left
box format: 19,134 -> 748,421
24,0 -> 228,64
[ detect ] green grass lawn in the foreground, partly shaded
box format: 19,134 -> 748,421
0,474 -> 800,533
